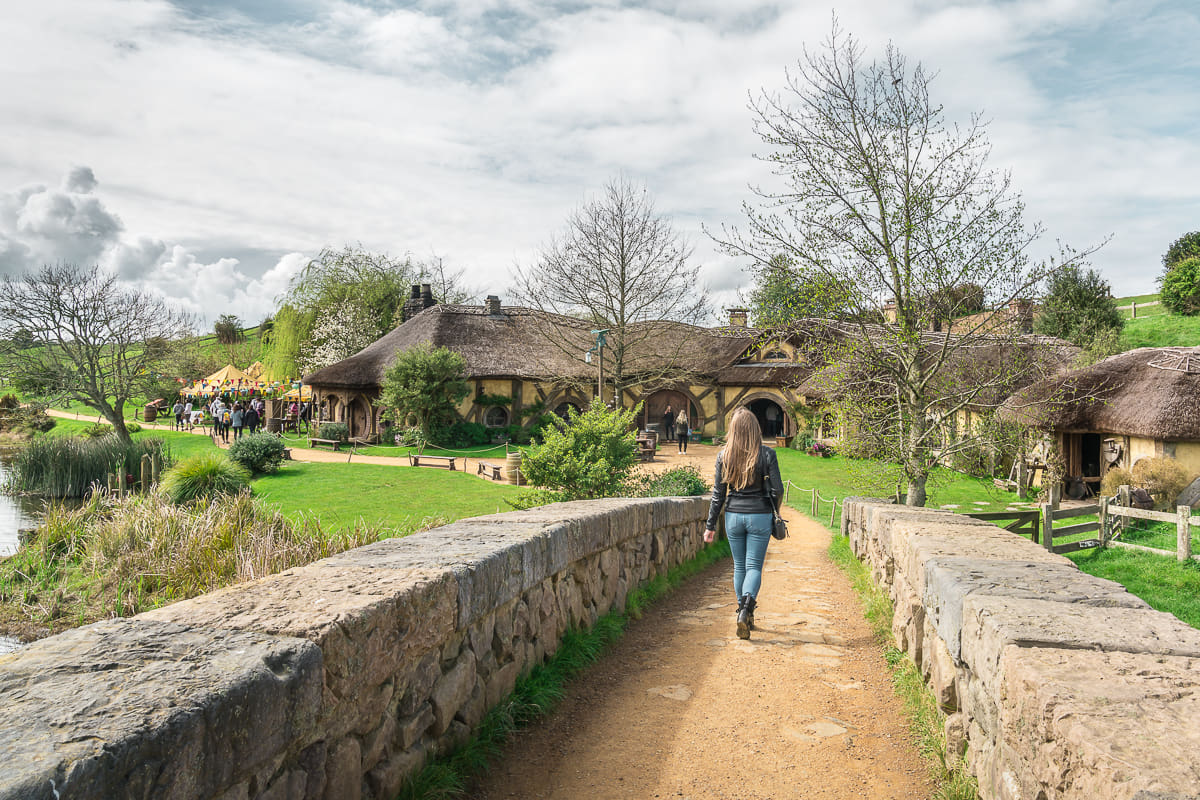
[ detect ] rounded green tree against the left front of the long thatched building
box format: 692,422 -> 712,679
379,343 -> 470,441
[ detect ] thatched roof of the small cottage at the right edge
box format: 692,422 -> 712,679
1001,348 -> 1200,440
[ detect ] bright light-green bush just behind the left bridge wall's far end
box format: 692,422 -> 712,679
521,398 -> 638,500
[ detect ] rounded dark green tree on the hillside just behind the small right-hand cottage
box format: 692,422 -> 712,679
1033,265 -> 1124,348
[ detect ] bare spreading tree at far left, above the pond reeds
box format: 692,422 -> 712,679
0,264 -> 192,440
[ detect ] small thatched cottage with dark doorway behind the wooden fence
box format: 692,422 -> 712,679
1002,347 -> 1200,485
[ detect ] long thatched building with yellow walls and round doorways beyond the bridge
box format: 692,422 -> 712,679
304,296 -> 810,443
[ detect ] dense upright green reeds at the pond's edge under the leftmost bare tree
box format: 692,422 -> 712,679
8,434 -> 172,498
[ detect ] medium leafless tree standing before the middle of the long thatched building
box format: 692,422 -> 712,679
514,172 -> 709,402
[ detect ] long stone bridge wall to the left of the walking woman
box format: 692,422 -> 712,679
0,498 -> 708,800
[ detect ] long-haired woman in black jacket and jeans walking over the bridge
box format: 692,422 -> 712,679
704,408 -> 784,639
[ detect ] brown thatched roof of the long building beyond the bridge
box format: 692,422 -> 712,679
304,305 -> 755,389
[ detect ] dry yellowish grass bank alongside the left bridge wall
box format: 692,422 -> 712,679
0,492 -> 415,639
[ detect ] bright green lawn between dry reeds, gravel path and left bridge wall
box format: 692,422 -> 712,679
253,462 -> 523,531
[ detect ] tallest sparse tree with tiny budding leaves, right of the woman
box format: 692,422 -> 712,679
716,20 -> 1096,505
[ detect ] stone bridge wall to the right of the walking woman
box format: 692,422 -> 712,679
842,499 -> 1200,800
